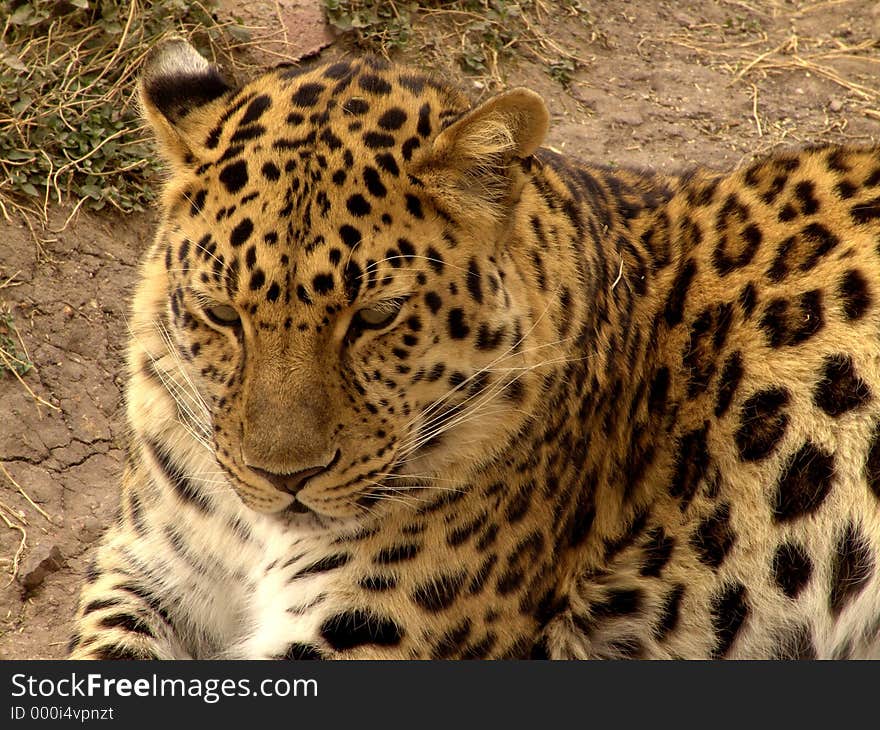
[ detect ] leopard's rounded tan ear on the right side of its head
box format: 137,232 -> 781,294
414,88 -> 550,222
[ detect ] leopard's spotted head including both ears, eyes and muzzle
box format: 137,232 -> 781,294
142,44 -> 552,518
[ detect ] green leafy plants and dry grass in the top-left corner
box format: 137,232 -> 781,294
0,0 -> 237,215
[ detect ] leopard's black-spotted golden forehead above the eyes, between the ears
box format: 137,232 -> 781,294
166,59 -> 468,307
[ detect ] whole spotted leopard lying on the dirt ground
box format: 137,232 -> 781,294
69,39 -> 880,660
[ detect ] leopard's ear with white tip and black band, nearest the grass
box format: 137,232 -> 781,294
140,40 -> 231,165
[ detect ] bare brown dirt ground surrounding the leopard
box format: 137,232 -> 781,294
0,0 -> 880,659
